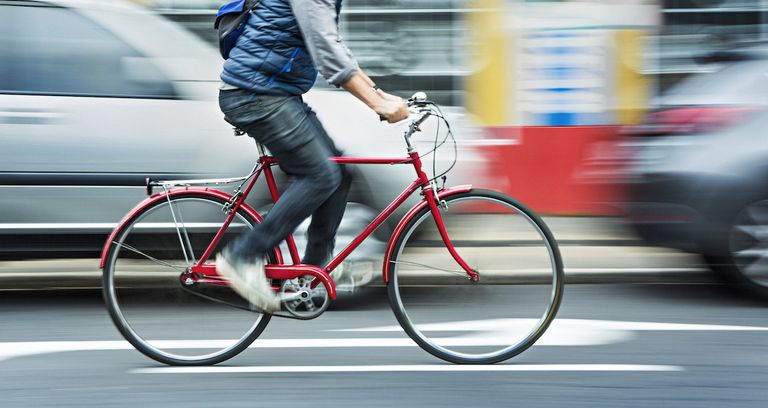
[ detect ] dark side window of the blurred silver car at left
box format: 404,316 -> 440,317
0,2 -> 175,98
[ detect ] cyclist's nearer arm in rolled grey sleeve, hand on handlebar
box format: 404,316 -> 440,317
291,0 -> 408,123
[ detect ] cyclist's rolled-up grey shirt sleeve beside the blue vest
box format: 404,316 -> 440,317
290,0 -> 359,86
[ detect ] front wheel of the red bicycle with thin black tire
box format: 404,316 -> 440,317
387,189 -> 564,364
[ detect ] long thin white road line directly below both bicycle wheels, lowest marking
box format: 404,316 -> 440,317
130,364 -> 685,374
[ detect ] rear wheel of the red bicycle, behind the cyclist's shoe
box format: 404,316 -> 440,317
103,193 -> 274,365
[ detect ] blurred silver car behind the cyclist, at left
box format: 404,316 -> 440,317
0,0 -> 482,259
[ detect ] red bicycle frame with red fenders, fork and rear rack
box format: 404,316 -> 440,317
101,110 -> 479,299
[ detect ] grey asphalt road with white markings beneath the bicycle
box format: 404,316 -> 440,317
0,284 -> 768,408
